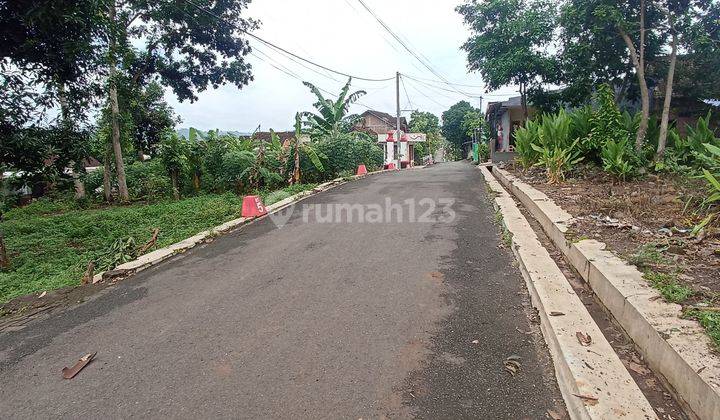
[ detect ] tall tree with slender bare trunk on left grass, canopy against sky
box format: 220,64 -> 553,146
105,0 -> 258,201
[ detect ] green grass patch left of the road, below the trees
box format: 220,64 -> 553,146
0,184 -> 314,303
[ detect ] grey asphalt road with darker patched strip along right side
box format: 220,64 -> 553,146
0,162 -> 564,419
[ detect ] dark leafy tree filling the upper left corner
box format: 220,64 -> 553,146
0,0 -> 102,176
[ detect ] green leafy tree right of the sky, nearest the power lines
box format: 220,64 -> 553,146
456,0 -> 557,119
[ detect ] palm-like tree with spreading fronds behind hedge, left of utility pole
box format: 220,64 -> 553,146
300,77 -> 366,137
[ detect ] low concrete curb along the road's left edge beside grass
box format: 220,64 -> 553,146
93,176 -> 352,283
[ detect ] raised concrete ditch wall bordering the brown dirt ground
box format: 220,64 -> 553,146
492,167 -> 720,419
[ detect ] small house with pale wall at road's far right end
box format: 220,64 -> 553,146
485,96 -> 535,162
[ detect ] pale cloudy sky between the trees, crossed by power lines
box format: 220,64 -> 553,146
167,0 -> 515,132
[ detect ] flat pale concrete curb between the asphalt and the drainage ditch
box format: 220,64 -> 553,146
478,166 -> 657,419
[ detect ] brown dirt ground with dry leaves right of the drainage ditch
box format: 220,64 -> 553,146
506,162 -> 720,305
